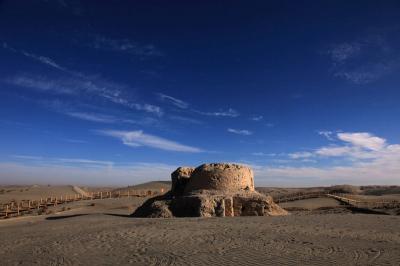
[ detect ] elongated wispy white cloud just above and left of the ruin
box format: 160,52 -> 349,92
98,130 -> 203,153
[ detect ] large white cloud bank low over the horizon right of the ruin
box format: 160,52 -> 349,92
256,132 -> 400,186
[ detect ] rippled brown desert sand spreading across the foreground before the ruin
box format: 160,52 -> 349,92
0,198 -> 400,265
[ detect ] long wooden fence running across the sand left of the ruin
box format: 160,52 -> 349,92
0,189 -> 164,219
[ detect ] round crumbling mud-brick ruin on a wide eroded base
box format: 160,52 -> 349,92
132,163 -> 287,218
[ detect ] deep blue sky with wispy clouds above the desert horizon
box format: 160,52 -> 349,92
0,0 -> 400,186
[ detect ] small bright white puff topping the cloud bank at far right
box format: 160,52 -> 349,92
337,132 -> 386,151
